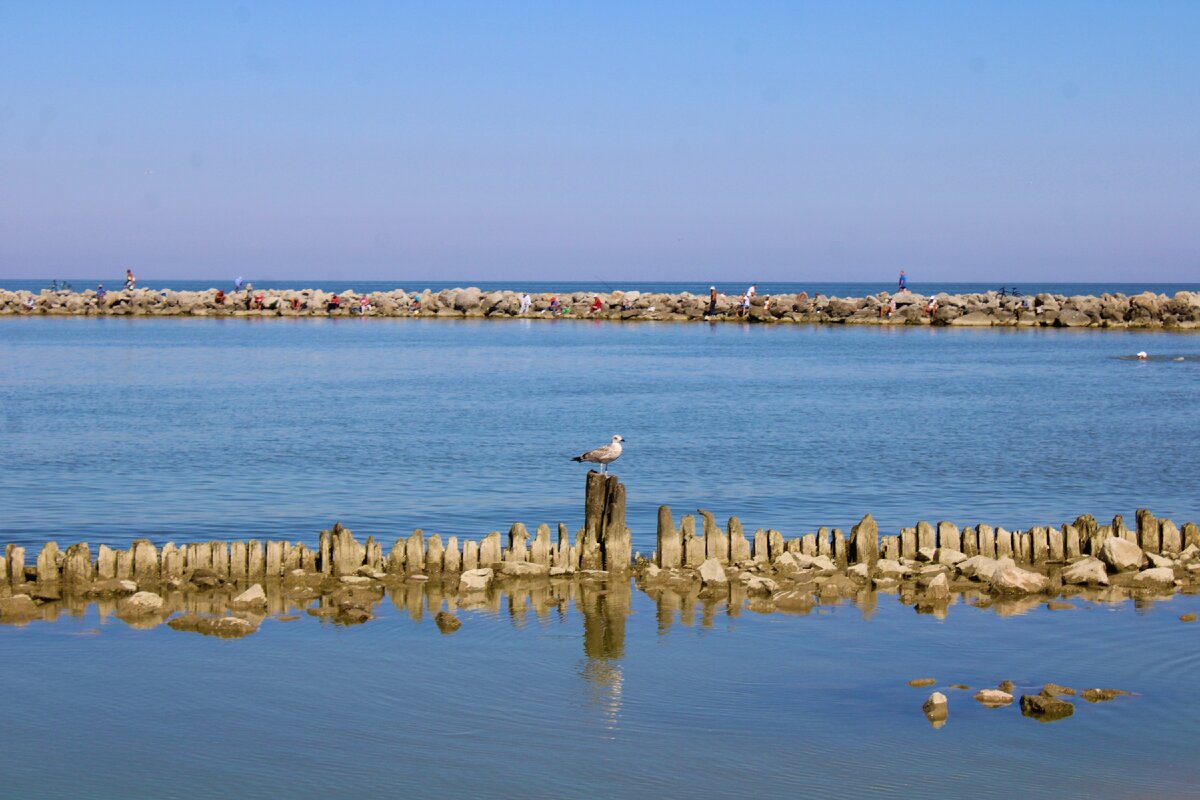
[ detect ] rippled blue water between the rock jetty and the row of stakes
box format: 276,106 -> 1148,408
0,318 -> 1200,553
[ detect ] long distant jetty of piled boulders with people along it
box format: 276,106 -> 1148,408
7,287 -> 1200,330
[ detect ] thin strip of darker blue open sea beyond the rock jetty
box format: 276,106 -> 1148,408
0,275 -> 1200,297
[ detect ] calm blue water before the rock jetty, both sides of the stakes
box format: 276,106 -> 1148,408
0,318 -> 1200,798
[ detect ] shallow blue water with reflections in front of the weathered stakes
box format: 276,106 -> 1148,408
0,585 -> 1200,799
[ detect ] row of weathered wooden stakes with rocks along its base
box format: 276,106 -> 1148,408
0,471 -> 1200,634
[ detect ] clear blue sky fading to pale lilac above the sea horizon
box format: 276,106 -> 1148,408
0,0 -> 1200,282
